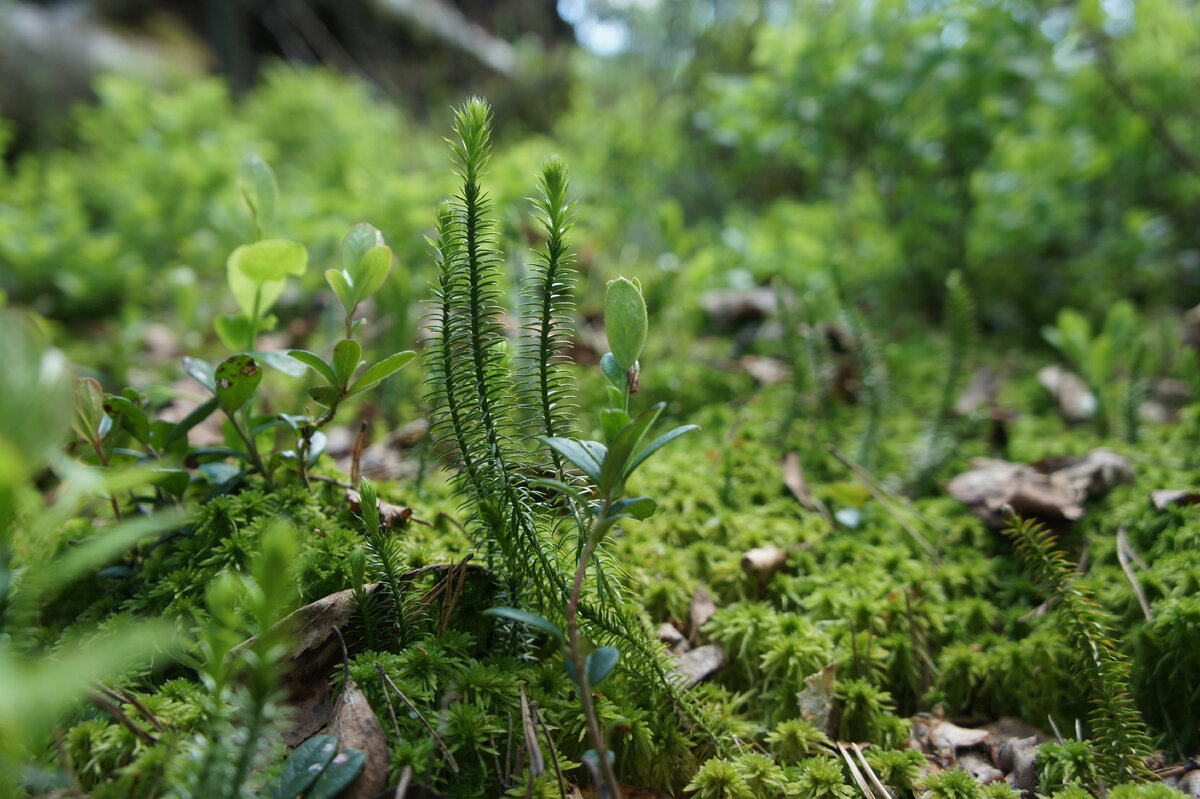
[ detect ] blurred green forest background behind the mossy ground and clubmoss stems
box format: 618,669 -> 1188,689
0,0 -> 1200,352
